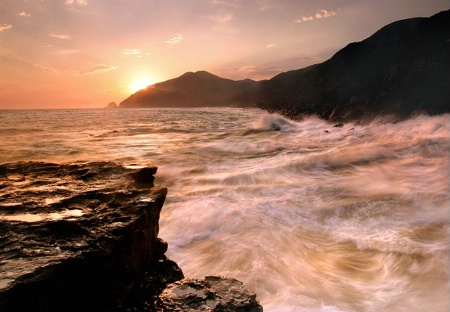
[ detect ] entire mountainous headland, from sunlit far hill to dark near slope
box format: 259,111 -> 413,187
119,10 -> 450,121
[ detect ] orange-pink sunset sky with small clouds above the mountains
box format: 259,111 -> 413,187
0,0 -> 450,109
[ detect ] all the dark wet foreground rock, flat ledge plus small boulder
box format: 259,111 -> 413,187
0,162 -> 262,312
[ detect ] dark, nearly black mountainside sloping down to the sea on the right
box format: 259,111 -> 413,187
253,11 -> 450,120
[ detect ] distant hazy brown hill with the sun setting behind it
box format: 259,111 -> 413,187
119,71 -> 257,107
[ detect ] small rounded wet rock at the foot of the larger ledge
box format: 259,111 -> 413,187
156,276 -> 263,312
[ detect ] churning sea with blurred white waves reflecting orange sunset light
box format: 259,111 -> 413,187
0,108 -> 450,311
